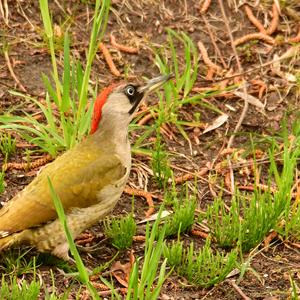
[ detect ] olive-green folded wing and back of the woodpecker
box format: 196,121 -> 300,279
0,151 -> 126,237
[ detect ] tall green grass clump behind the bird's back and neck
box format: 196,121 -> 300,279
0,0 -> 110,156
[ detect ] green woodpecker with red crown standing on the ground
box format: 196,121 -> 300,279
0,74 -> 172,261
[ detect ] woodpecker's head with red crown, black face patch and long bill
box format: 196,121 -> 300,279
90,75 -> 172,134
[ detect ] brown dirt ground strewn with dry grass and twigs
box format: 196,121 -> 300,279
0,0 -> 300,299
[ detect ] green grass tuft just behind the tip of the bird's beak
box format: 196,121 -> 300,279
130,29 -> 216,154
